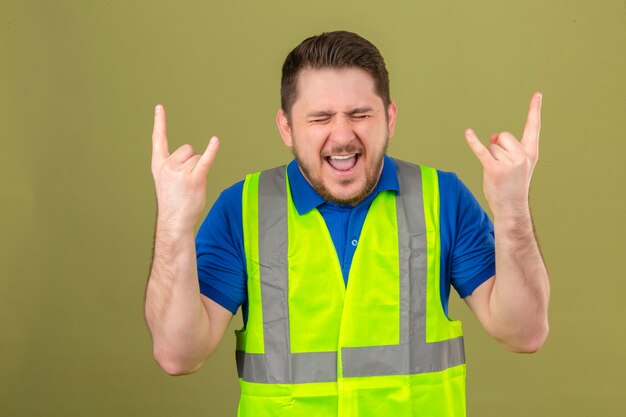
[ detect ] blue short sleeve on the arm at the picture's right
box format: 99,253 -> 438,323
440,173 -> 496,298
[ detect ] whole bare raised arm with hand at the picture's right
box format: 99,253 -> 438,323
465,93 -> 550,352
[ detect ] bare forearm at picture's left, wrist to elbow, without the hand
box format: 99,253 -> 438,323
145,224 -> 211,374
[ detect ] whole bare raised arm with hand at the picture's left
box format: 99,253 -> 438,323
144,105 -> 232,375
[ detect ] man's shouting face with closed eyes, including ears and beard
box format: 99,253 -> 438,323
276,68 -> 396,204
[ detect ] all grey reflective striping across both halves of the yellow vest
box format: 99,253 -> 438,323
237,160 -> 465,384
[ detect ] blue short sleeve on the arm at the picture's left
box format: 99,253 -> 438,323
196,181 -> 246,314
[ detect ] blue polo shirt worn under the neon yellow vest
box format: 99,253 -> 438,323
196,156 -> 495,320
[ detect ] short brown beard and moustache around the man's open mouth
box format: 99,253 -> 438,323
291,138 -> 389,206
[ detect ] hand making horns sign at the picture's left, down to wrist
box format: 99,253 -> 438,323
152,104 -> 219,230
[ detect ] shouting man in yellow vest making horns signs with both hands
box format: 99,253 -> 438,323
145,32 -> 549,416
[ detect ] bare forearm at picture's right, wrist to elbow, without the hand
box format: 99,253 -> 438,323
489,207 -> 550,352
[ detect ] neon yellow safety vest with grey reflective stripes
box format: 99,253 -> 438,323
236,160 -> 465,417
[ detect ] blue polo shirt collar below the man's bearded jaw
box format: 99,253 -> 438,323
287,155 -> 400,214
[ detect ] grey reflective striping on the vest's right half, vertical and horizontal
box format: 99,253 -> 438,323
341,160 -> 465,377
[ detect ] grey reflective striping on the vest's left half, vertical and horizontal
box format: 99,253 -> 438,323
236,166 -> 337,384
